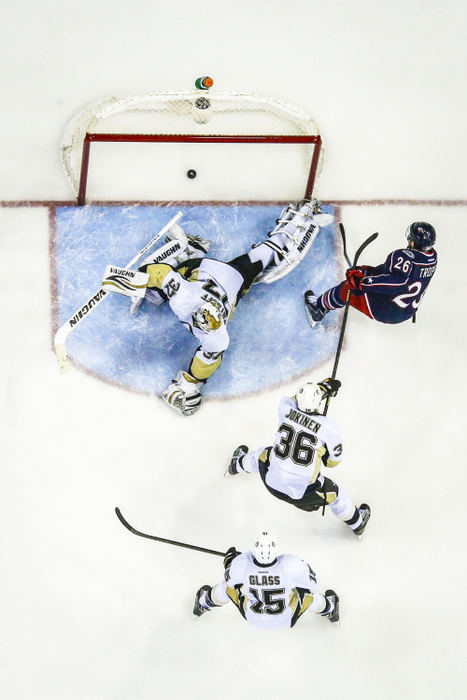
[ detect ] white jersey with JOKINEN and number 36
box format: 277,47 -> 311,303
266,397 -> 342,499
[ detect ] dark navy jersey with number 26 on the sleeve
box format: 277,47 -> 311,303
361,248 -> 437,323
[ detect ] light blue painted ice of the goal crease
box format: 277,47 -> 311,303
55,205 -> 340,397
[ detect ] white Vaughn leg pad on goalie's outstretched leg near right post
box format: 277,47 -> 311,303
255,199 -> 334,284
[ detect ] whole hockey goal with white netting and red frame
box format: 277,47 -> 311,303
61,90 -> 324,204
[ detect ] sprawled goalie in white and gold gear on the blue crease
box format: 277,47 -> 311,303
126,200 -> 333,416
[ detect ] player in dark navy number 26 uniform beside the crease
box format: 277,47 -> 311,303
305,221 -> 437,327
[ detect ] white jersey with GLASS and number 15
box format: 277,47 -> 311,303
223,552 -> 326,629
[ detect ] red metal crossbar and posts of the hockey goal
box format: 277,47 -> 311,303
78,132 -> 322,206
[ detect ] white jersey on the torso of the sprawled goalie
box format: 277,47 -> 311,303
161,258 -> 243,353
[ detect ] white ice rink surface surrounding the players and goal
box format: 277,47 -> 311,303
0,0 -> 467,700
